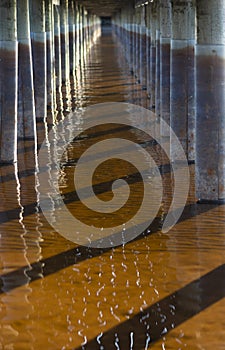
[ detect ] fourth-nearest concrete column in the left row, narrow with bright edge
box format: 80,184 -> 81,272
45,0 -> 56,113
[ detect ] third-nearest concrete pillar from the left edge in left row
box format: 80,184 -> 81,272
29,0 -> 47,120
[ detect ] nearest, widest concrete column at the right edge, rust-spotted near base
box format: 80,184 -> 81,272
196,0 -> 225,203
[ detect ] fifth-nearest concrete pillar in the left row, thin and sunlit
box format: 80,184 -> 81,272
53,6 -> 63,111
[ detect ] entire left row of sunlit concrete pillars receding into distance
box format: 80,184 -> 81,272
0,0 -> 101,163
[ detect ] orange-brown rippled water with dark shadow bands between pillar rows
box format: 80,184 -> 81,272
0,26 -> 225,350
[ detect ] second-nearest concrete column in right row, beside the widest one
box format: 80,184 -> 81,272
170,0 -> 195,160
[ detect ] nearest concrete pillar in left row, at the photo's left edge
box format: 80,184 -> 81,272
0,0 -> 18,163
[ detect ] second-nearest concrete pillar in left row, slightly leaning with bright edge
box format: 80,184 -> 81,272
17,0 -> 36,139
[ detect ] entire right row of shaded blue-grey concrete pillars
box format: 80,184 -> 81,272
113,0 -> 225,202
